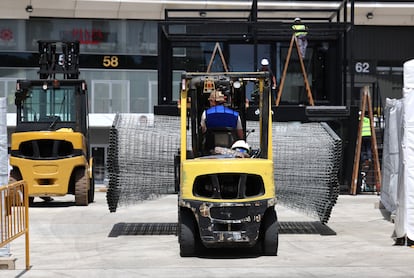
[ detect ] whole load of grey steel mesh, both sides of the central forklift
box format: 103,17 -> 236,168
107,114 -> 342,223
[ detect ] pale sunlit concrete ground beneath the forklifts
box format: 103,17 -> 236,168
0,191 -> 414,278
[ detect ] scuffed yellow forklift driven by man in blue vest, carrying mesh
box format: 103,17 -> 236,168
175,72 -> 278,257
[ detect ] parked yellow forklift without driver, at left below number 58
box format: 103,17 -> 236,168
9,41 -> 95,206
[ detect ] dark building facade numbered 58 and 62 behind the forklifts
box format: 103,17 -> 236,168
0,9 -> 414,187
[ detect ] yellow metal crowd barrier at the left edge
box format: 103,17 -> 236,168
0,181 -> 30,270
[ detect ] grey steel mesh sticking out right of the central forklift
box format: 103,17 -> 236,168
248,122 -> 342,223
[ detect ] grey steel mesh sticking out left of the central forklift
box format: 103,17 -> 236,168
107,114 -> 180,212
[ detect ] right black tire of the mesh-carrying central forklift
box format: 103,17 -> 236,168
262,208 -> 279,256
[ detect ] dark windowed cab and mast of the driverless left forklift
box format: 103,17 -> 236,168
15,41 -> 88,136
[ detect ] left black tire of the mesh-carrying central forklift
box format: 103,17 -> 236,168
178,211 -> 196,257
